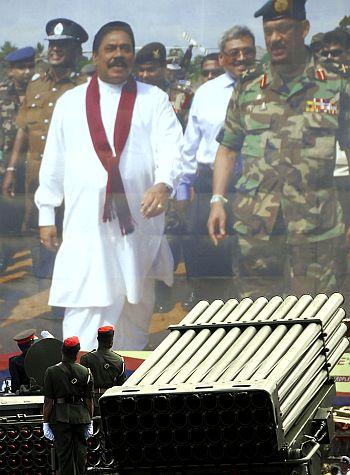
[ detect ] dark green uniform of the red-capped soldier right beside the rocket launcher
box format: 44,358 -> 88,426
80,348 -> 126,413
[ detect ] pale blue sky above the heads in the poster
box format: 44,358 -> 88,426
0,0 -> 350,50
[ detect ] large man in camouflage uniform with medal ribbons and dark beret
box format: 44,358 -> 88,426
208,0 -> 350,298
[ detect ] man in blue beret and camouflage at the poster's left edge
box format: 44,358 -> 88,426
0,46 -> 35,272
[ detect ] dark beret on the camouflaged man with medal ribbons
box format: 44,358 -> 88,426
254,0 -> 306,21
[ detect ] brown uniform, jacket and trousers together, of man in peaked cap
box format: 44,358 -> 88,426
17,70 -> 86,230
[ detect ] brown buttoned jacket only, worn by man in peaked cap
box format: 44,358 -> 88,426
17,71 -> 86,160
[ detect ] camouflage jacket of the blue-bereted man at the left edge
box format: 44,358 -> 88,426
0,79 -> 25,160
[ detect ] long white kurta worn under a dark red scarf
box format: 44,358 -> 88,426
35,80 -> 182,307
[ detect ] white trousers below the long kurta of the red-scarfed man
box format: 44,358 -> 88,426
63,278 -> 154,351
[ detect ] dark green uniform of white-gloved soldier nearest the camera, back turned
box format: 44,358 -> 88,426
44,362 -> 93,475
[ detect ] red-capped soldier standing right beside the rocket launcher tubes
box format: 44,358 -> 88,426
80,326 -> 126,415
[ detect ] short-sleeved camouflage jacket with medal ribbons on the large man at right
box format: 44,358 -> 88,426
219,57 -> 350,244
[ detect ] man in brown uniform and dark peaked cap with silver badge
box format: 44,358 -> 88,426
3,18 -> 88,277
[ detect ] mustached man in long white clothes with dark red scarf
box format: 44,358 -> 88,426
35,21 -> 182,350
